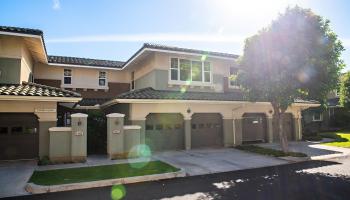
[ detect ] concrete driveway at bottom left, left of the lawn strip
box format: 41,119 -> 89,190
0,160 -> 37,198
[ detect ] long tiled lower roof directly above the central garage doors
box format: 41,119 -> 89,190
117,87 -> 244,101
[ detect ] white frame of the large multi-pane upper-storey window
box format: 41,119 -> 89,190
168,56 -> 213,86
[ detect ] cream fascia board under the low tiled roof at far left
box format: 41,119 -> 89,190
0,95 -> 82,103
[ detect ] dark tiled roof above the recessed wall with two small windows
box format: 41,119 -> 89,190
48,56 -> 124,68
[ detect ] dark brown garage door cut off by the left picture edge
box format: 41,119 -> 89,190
0,113 -> 39,160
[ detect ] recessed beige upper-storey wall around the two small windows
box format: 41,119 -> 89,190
34,63 -> 130,89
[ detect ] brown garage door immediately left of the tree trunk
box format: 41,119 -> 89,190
242,113 -> 267,143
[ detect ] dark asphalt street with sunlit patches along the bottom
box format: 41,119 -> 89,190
3,158 -> 350,200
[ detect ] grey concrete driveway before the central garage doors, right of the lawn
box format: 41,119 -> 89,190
153,148 -> 288,176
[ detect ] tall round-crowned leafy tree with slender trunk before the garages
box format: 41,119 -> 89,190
237,6 -> 344,152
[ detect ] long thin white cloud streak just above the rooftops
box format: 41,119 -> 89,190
47,33 -> 245,43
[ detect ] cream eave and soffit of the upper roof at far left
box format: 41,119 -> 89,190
0,31 -> 48,63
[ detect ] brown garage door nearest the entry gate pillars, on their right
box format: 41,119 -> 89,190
145,113 -> 185,151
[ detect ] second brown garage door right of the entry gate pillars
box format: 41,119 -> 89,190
191,113 -> 223,148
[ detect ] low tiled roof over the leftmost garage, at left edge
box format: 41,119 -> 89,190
0,82 -> 81,97
